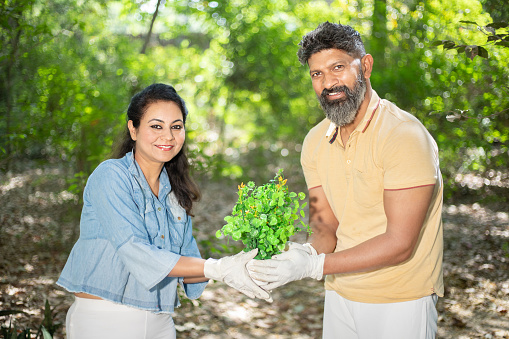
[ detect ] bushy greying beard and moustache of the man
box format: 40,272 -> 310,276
318,69 -> 366,126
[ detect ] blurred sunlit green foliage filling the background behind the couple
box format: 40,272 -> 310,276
0,0 -> 509,203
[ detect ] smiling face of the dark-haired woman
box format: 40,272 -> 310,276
127,101 -> 186,169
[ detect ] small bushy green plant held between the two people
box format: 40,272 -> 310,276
216,169 -> 311,259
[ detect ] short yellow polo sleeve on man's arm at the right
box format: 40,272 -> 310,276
380,121 -> 440,190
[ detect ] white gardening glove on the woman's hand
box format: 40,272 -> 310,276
203,249 -> 271,301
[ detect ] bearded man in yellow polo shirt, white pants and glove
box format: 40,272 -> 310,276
248,22 -> 444,339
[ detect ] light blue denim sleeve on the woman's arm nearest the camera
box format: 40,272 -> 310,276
85,162 -> 180,289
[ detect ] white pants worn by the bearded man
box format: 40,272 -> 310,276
323,291 -> 438,339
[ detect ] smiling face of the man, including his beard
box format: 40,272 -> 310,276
308,49 -> 366,126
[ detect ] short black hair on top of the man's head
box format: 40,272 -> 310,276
297,21 -> 366,65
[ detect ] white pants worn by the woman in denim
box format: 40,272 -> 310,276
66,297 -> 177,339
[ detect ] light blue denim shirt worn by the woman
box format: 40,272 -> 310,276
57,152 -> 207,313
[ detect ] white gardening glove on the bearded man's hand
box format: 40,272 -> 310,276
248,244 -> 325,291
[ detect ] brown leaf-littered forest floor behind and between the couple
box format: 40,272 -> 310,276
0,163 -> 509,339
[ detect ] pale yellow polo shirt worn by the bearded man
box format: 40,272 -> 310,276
301,91 -> 444,303
